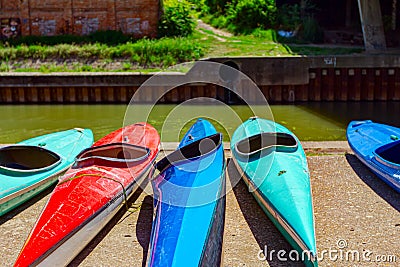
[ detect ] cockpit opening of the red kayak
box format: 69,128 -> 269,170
76,143 -> 150,166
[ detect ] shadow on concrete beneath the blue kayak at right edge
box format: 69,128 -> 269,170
346,154 -> 400,211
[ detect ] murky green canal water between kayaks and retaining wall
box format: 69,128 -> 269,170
0,102 -> 400,144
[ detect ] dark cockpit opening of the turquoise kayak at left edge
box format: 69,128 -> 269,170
0,145 -> 61,173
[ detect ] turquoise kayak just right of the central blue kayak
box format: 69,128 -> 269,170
231,118 -> 318,266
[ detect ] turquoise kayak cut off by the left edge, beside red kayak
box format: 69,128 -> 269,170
0,128 -> 93,215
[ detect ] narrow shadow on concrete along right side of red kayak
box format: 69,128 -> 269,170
67,179 -> 148,267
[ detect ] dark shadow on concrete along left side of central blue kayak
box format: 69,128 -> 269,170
136,196 -> 153,267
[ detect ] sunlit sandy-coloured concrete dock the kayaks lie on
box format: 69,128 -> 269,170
0,142 -> 400,267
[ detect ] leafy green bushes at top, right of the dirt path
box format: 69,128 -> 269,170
197,0 -> 323,42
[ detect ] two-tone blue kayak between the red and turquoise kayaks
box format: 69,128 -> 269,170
147,119 -> 225,267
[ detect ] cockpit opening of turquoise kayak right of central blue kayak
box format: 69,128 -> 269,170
235,132 -> 298,156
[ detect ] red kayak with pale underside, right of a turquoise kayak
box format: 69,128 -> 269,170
15,123 -> 160,266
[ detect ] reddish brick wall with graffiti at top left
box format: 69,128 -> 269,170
0,0 -> 161,38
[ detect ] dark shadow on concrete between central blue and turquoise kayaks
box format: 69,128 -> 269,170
228,161 -> 304,267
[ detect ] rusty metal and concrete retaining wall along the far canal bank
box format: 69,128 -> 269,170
0,55 -> 400,103
